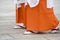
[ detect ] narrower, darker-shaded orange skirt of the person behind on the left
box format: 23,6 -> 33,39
16,3 -> 25,23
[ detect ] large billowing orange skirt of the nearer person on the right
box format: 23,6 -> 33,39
26,0 -> 59,31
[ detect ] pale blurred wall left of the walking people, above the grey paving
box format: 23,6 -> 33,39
0,0 -> 15,16
